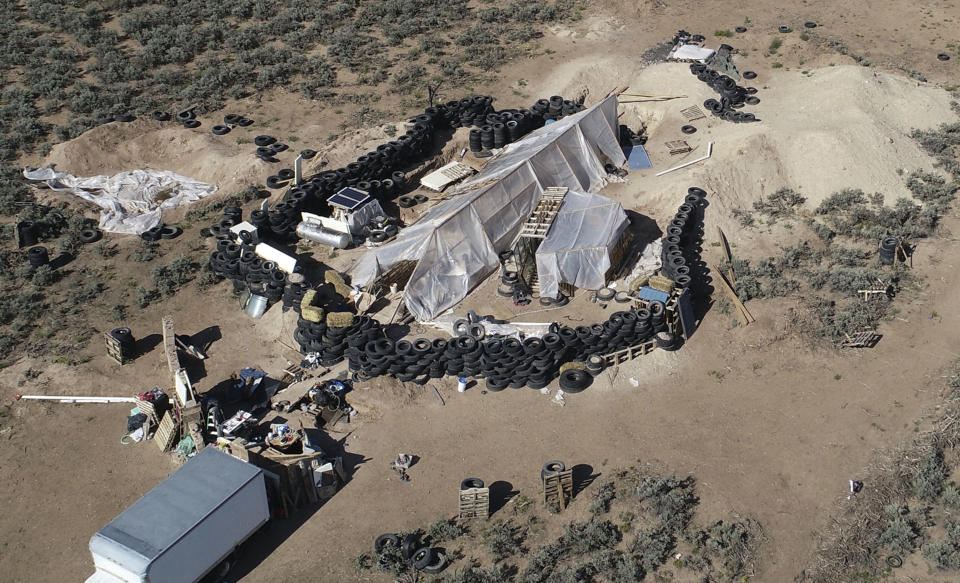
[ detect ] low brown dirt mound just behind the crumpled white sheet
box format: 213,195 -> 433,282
39,119 -> 268,193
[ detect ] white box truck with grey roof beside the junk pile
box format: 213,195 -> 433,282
86,447 -> 270,583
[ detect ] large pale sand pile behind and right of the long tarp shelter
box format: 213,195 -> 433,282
551,60 -> 956,230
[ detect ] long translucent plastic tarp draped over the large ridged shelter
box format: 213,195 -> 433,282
351,96 -> 625,321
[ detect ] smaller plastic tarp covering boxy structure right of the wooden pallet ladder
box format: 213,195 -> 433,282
537,191 -> 629,298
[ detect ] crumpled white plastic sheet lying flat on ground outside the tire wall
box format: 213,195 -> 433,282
23,168 -> 217,235
